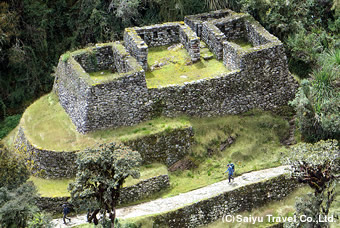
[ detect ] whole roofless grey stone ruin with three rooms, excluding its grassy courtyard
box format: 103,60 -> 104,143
54,9 -> 298,133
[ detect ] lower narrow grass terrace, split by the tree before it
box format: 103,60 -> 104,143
29,163 -> 168,197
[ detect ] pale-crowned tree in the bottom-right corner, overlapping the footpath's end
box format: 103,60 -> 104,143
285,140 -> 340,228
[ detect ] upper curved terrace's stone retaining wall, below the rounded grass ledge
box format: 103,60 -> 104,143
15,127 -> 193,178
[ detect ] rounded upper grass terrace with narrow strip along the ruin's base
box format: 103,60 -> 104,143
21,93 -> 190,151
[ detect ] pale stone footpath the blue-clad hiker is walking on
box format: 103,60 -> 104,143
52,166 -> 289,228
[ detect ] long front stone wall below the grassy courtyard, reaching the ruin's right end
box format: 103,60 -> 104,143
150,67 -> 297,117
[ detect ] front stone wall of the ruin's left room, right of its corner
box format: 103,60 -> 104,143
87,72 -> 150,131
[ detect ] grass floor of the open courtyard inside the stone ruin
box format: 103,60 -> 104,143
145,43 -> 229,88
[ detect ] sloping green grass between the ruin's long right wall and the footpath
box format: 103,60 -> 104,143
164,111 -> 289,197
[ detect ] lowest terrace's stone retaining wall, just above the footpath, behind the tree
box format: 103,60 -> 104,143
35,175 -> 170,214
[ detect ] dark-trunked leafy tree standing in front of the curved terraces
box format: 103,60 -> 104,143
69,143 -> 142,227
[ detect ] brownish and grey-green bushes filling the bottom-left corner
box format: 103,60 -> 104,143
0,144 -> 52,228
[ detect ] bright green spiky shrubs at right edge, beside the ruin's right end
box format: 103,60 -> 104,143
291,49 -> 340,142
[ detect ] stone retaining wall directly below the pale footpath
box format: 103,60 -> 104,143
149,175 -> 298,228
